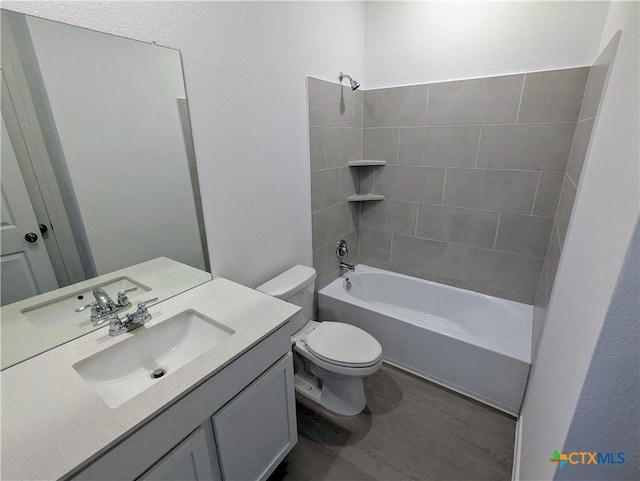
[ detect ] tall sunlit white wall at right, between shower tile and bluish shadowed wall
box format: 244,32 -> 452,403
520,2 -> 640,480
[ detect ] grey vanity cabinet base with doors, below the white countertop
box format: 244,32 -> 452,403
67,325 -> 297,481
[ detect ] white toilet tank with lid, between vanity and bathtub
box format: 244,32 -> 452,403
256,265 -> 316,332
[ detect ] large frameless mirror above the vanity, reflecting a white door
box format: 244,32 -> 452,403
0,10 -> 210,368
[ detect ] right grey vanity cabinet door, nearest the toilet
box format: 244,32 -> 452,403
213,353 -> 298,481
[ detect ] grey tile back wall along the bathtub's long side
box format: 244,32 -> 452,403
359,67 -> 589,304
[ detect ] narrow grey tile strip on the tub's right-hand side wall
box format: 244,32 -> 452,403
531,34 -> 618,357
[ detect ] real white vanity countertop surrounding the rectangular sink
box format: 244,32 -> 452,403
0,278 -> 300,480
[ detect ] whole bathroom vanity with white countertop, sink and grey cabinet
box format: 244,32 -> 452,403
0,279 -> 300,480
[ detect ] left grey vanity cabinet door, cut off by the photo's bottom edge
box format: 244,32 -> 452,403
138,422 -> 220,481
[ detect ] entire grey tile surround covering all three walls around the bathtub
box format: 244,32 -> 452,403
308,62 -> 606,316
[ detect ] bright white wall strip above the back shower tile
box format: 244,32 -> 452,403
363,1 -> 607,89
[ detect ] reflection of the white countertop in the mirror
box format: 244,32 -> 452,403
0,257 -> 211,369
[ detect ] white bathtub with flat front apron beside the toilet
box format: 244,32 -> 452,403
318,265 -> 533,415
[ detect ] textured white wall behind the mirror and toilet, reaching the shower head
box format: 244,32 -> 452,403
2,1 -> 364,286
